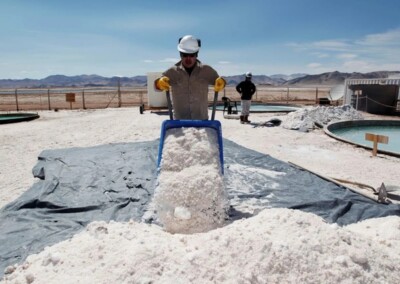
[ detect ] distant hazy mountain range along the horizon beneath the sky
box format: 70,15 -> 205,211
0,71 -> 400,88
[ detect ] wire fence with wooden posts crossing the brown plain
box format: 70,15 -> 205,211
0,85 -> 330,111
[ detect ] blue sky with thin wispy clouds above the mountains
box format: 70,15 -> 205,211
0,0 -> 400,79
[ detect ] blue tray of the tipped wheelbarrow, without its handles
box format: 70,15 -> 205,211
157,120 -> 224,174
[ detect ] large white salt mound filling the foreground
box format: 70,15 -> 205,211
3,209 -> 400,283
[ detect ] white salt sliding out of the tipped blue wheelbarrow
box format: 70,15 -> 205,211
152,127 -> 228,234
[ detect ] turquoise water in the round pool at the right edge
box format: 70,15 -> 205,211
331,126 -> 400,153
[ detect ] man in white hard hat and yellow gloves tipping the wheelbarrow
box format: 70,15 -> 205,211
154,35 -> 226,120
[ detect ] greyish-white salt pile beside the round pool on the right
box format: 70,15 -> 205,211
282,105 -> 363,132
